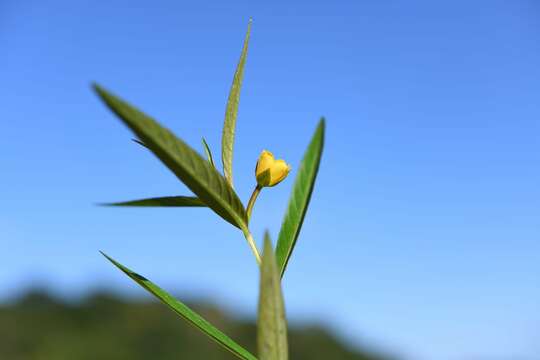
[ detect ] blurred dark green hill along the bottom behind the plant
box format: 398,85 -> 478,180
0,291 -> 394,360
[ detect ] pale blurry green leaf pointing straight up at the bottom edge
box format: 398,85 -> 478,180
257,232 -> 289,360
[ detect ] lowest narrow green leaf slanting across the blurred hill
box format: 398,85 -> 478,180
101,252 -> 257,360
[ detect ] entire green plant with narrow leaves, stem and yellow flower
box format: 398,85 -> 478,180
94,21 -> 325,360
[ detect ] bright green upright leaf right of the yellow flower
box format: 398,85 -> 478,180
276,118 -> 325,277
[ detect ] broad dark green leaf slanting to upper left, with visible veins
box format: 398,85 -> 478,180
94,85 -> 247,230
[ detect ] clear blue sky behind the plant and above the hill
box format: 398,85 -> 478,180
0,0 -> 540,360
